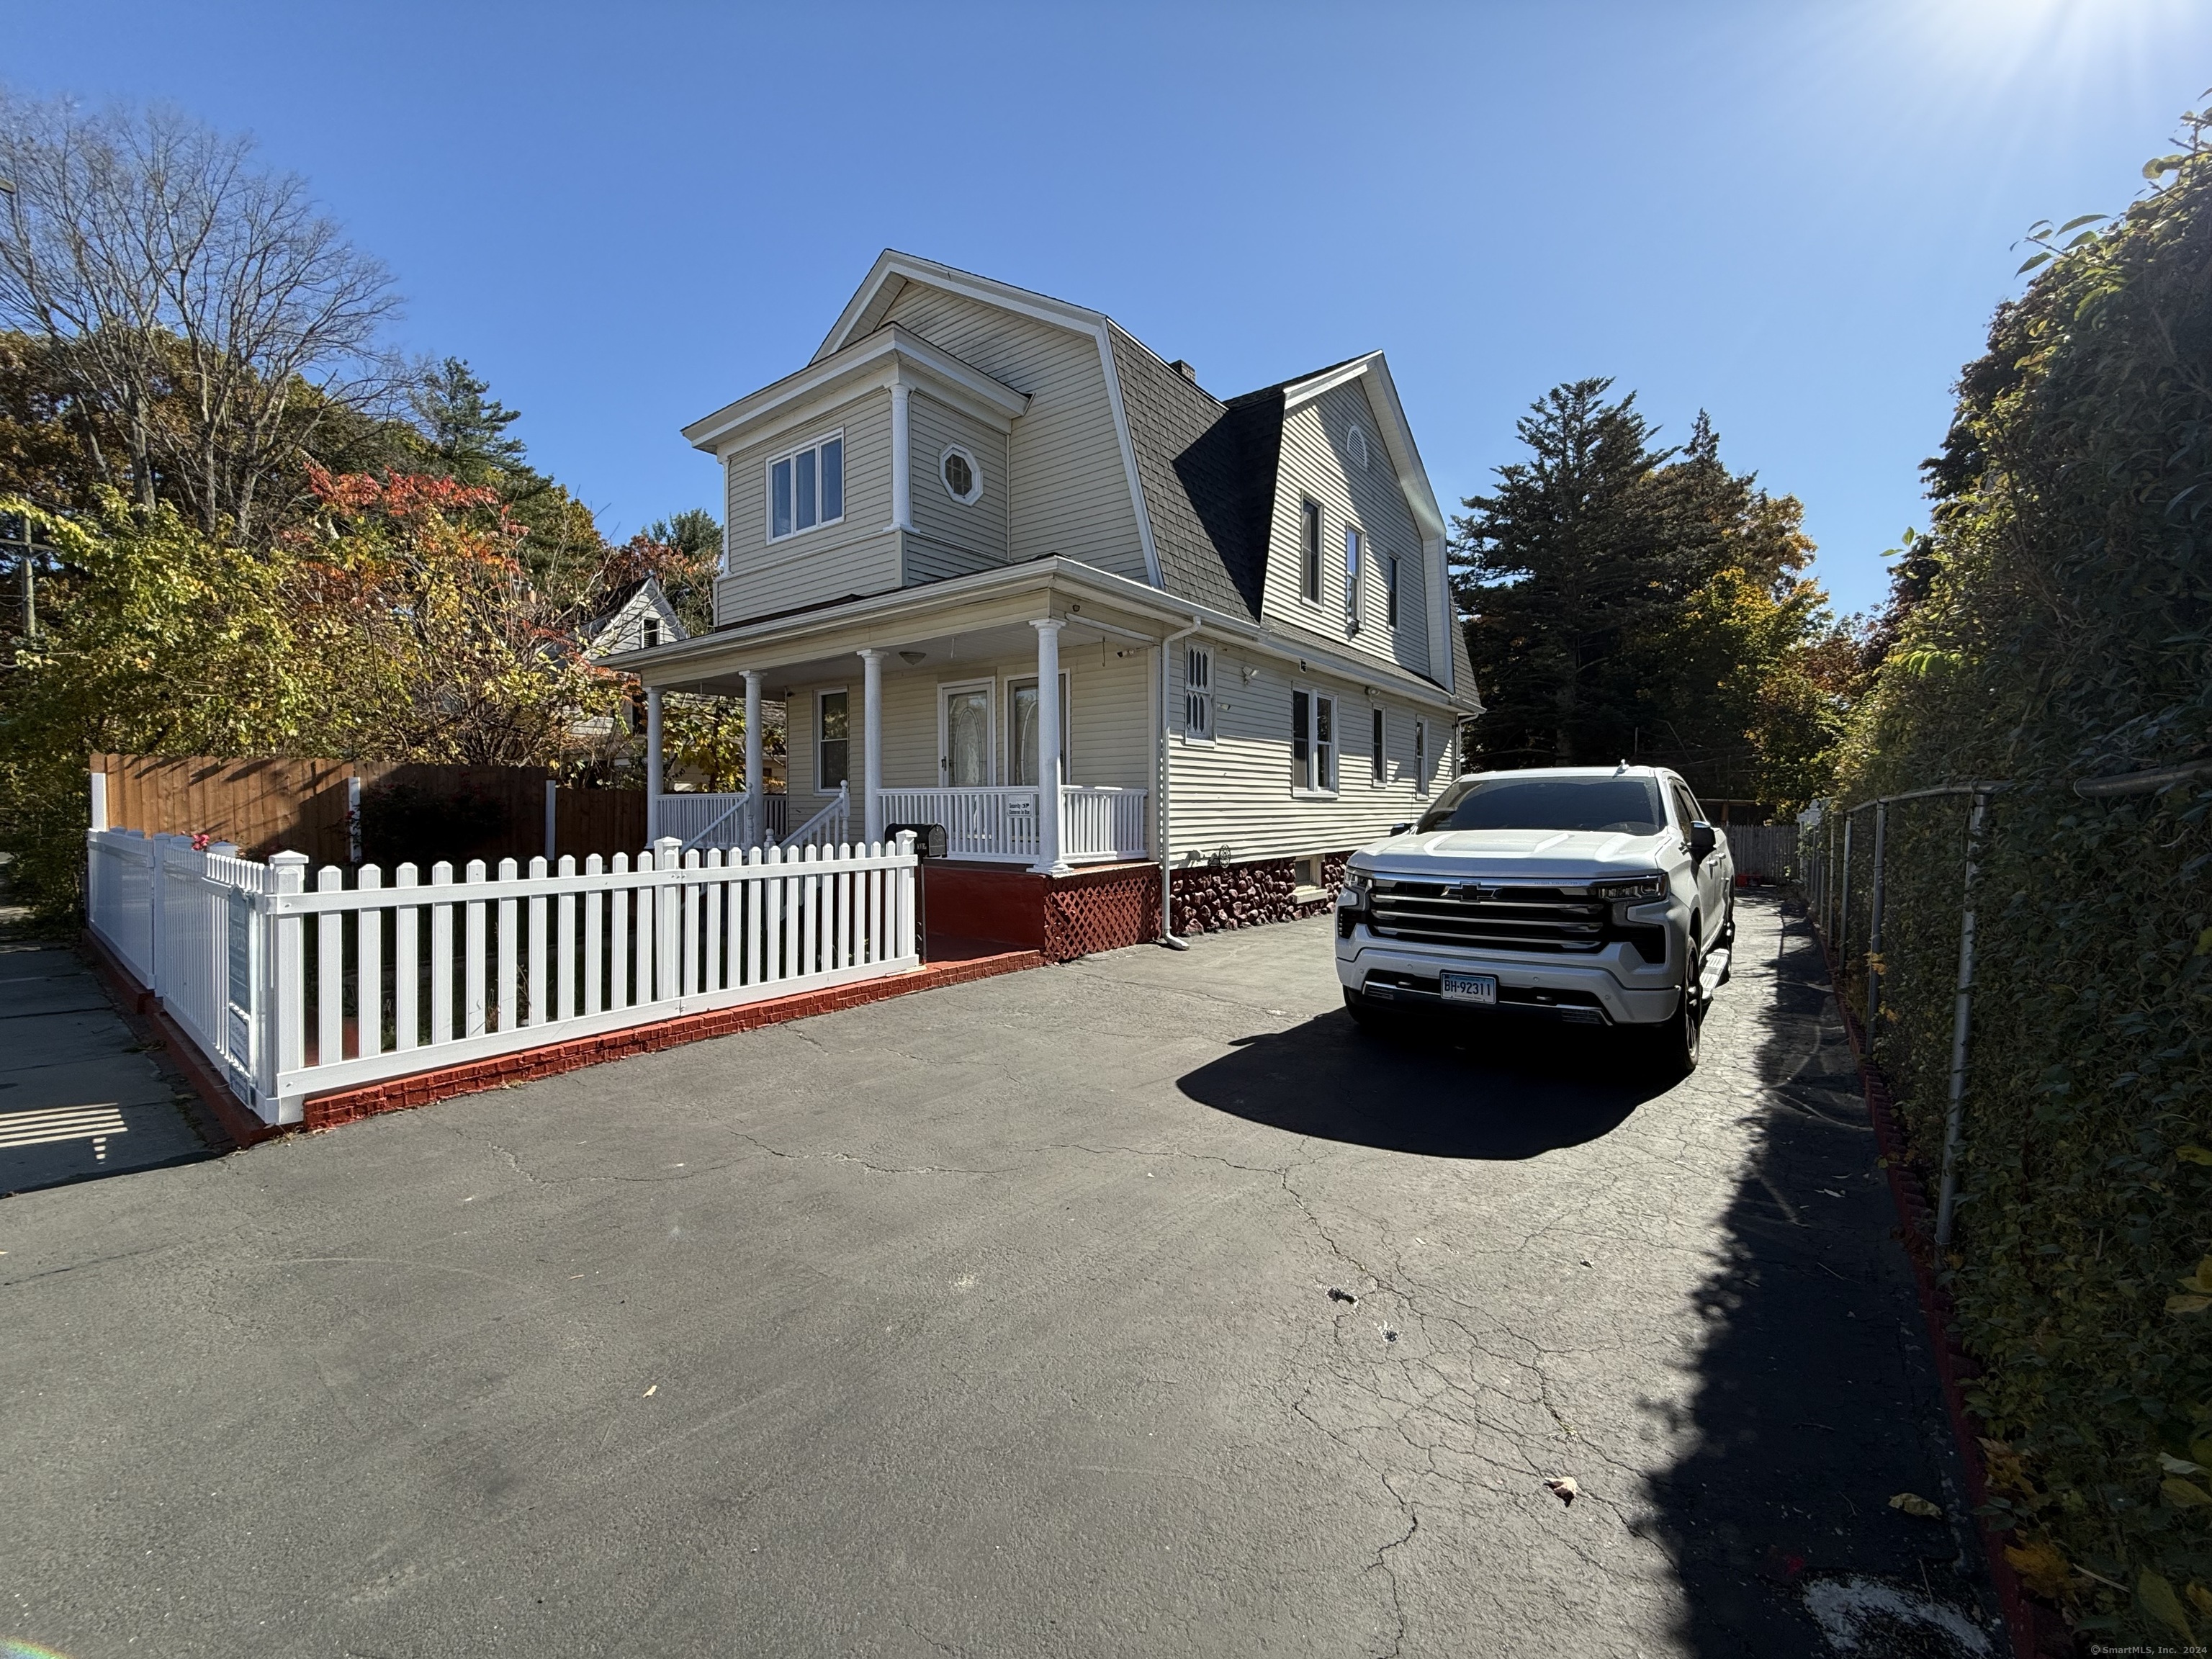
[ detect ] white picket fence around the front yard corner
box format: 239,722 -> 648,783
86,830 -> 920,1124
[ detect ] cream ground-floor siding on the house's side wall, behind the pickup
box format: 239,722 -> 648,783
1168,644 -> 1451,863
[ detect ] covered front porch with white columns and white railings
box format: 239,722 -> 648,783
642,573 -> 1166,876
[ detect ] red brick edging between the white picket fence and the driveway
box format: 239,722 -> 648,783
305,951 -> 1044,1128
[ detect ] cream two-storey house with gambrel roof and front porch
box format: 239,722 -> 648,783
613,252 -> 1482,953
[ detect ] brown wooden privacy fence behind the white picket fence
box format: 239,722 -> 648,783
91,755 -> 648,865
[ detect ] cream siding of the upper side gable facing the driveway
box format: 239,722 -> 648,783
1261,380 -> 1434,677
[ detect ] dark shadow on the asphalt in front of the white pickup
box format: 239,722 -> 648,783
1177,1011 -> 1661,1161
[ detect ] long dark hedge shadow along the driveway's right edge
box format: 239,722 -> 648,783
1648,916 -> 2004,1659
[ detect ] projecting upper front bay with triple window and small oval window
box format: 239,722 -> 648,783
683,323 -> 1028,624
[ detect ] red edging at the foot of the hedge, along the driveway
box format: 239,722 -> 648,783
1814,931 -> 2077,1659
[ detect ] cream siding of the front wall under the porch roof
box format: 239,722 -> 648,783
786,646 -> 1159,801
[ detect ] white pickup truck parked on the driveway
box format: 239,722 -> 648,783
1336,765 -> 1737,1077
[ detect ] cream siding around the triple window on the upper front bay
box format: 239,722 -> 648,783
714,390 -> 900,621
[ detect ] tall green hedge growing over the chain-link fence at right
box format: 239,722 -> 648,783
1843,126 -> 2212,1641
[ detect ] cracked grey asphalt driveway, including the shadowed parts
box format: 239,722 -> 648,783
0,902 -> 1995,1659
